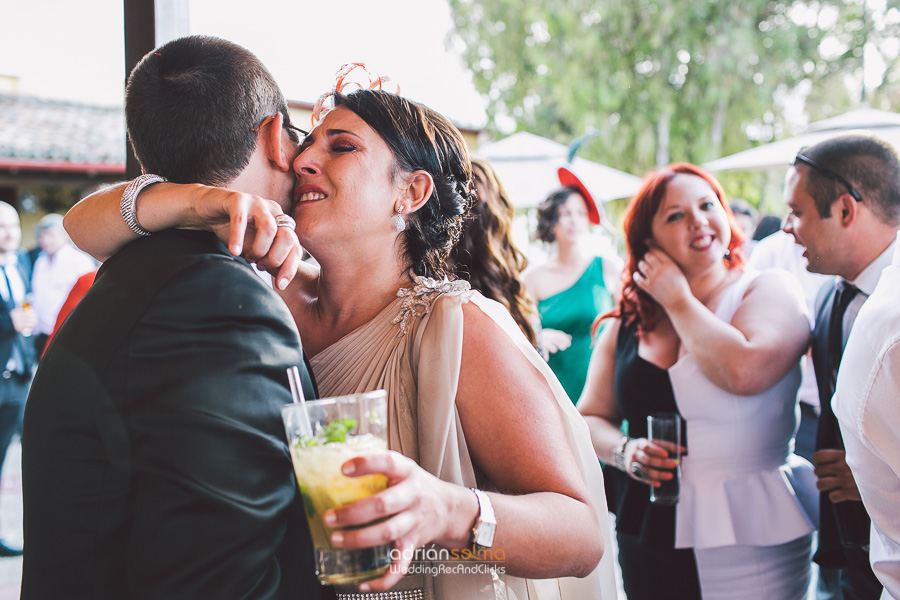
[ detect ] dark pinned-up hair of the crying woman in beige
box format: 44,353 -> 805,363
333,89 -> 475,278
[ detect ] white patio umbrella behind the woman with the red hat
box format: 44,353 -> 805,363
473,131 -> 641,208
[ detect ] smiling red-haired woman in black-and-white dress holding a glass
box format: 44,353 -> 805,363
578,164 -> 817,600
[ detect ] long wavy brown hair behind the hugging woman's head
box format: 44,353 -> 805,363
449,158 -> 539,346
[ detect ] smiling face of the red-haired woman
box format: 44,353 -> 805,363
652,174 -> 731,272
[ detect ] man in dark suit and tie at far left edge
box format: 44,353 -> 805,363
0,202 -> 37,556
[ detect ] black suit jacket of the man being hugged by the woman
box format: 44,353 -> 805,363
22,230 -> 323,600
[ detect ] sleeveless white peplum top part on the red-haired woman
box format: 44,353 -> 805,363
669,271 -> 819,549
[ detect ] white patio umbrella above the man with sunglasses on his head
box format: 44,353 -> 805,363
703,108 -> 900,171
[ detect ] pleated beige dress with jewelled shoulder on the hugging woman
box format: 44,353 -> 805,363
311,277 -> 616,600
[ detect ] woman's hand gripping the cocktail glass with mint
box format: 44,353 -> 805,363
324,452 -> 478,592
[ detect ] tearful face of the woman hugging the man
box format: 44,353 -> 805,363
294,106 -> 401,248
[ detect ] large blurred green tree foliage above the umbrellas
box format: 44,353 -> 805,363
449,0 -> 868,173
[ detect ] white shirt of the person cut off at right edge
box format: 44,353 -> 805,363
832,231 -> 900,600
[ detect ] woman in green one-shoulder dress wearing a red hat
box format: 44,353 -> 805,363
525,167 -> 621,403
